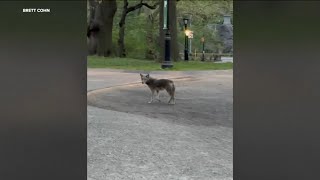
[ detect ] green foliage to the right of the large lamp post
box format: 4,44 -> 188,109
177,0 -> 233,52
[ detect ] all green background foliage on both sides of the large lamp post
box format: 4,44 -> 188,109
87,0 -> 233,59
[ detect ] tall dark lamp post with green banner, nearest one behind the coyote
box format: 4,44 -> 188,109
161,0 -> 173,69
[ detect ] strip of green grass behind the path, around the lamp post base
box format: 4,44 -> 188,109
88,56 -> 233,71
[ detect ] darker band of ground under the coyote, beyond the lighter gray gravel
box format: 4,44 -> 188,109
88,74 -> 233,127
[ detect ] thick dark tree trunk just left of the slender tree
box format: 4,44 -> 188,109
94,0 -> 117,57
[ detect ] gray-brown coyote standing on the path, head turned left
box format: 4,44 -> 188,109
140,74 -> 176,104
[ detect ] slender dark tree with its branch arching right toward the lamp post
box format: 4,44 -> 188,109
118,0 -> 158,57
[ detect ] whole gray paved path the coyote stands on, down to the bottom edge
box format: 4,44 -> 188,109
88,69 -> 233,180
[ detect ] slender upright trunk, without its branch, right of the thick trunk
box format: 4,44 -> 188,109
118,0 -> 128,57
